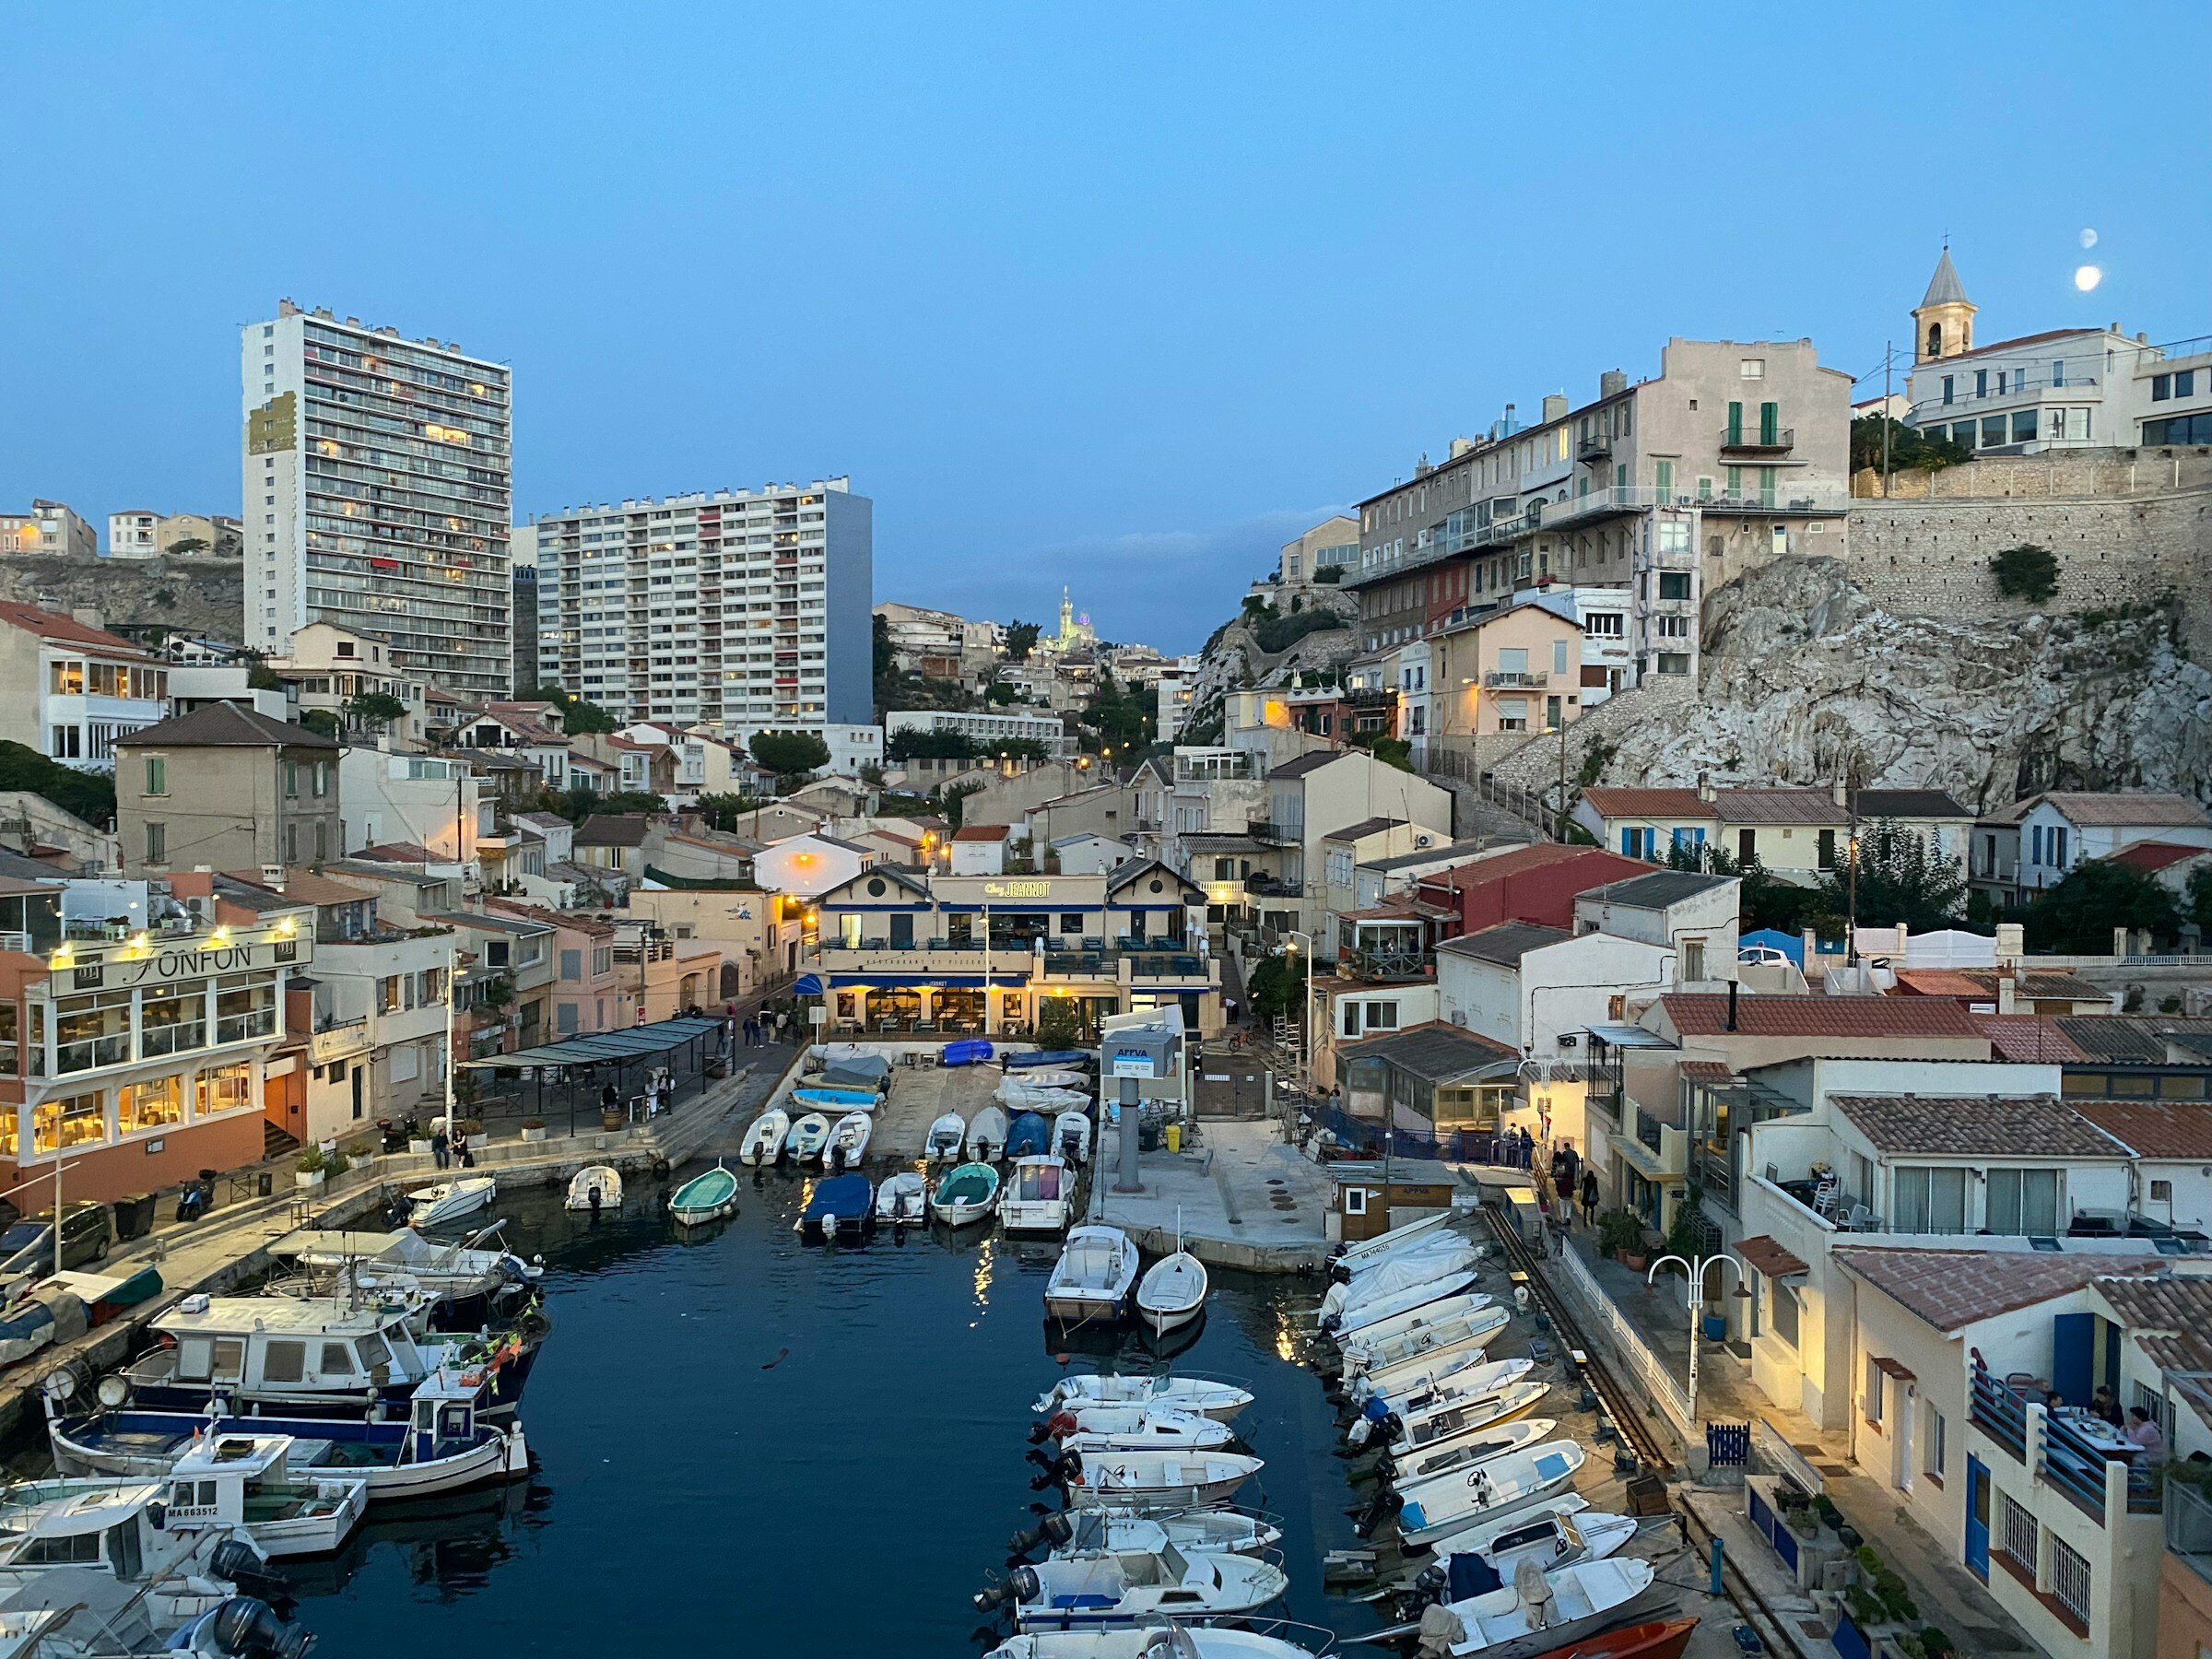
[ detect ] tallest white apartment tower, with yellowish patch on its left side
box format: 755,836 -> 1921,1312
239,300 -> 513,697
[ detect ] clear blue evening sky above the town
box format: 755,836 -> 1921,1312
0,0 -> 2212,648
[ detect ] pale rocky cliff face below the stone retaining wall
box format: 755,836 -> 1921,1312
1604,559 -> 2212,807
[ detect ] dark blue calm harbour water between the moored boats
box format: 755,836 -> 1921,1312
285,1177 -> 1371,1659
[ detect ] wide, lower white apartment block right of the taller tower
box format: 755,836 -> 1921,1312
533,477 -> 874,730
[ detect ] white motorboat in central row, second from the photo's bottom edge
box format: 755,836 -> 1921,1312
975,1544 -> 1289,1630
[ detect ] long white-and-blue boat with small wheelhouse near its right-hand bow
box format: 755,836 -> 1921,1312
42,1370 -> 531,1502
